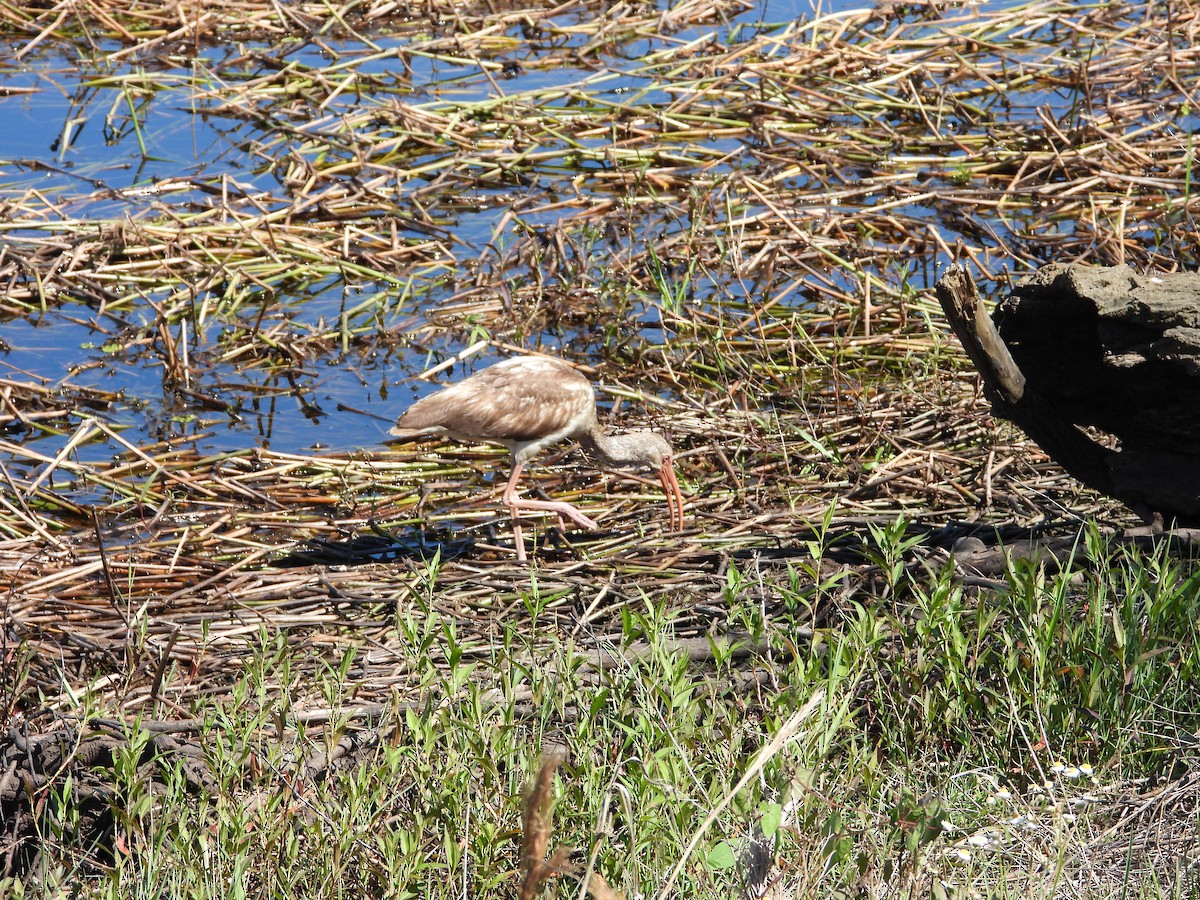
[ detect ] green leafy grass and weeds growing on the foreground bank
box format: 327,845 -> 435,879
10,528 -> 1200,898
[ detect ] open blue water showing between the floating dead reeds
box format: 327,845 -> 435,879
0,0 -> 1200,465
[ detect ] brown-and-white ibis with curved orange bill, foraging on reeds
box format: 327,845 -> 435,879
391,356 -> 683,560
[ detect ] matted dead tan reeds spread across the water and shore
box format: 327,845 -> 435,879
0,0 -> 1200,897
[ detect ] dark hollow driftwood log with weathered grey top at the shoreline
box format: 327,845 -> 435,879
936,264 -> 1200,526
